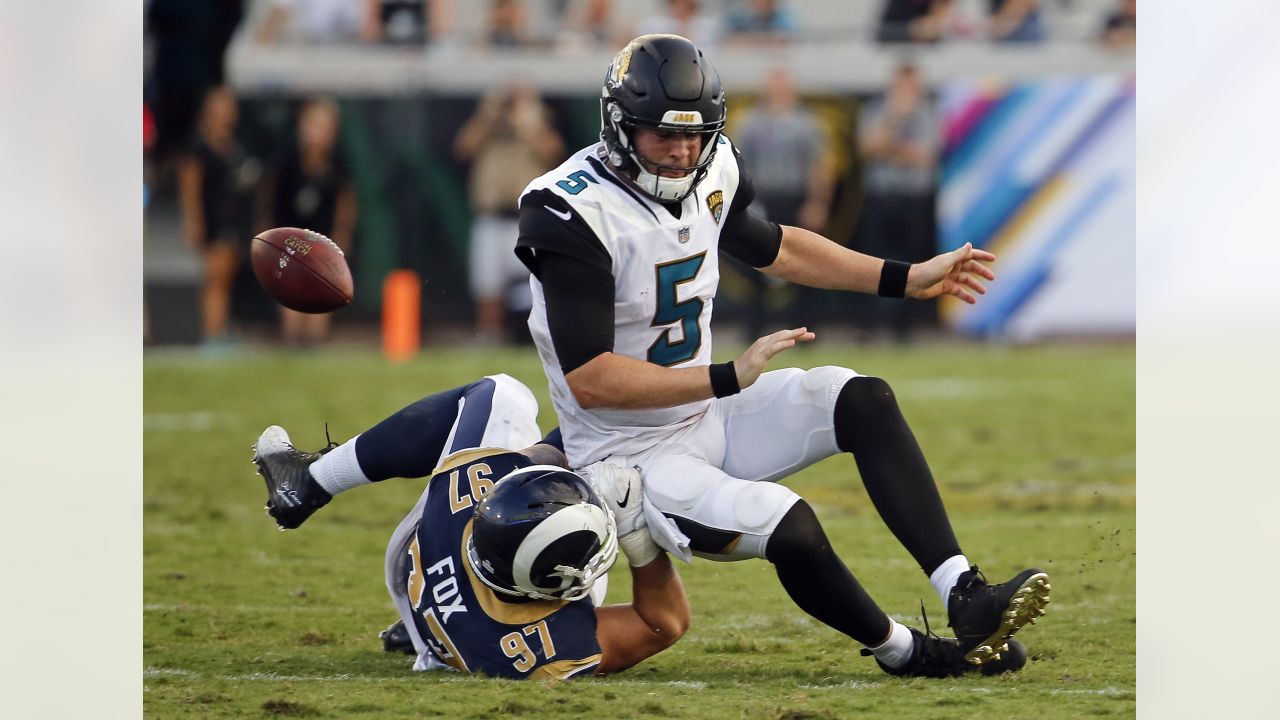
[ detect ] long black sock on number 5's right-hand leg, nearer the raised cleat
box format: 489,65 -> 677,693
836,378 -> 960,575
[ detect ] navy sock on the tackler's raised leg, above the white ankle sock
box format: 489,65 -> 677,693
356,384 -> 475,483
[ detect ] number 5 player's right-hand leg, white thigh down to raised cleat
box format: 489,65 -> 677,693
716,366 -> 1050,662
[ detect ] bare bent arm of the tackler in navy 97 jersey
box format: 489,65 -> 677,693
595,553 -> 690,675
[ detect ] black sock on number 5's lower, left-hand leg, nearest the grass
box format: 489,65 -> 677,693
764,500 -> 891,647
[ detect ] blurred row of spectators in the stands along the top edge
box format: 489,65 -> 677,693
244,0 -> 1135,49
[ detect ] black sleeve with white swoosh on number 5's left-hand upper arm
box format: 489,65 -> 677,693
516,184 -> 614,374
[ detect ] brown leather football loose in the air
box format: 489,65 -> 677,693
250,228 -> 355,313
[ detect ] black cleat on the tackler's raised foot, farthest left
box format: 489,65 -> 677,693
253,425 -> 337,530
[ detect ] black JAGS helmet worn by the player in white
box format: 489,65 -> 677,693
600,35 -> 724,202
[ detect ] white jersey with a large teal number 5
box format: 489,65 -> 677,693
521,135 -> 740,466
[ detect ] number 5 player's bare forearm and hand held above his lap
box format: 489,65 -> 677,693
564,328 -> 814,409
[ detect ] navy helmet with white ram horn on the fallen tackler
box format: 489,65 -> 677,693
467,465 -> 618,600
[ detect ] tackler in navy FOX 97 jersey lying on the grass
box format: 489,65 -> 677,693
253,375 -> 689,679
